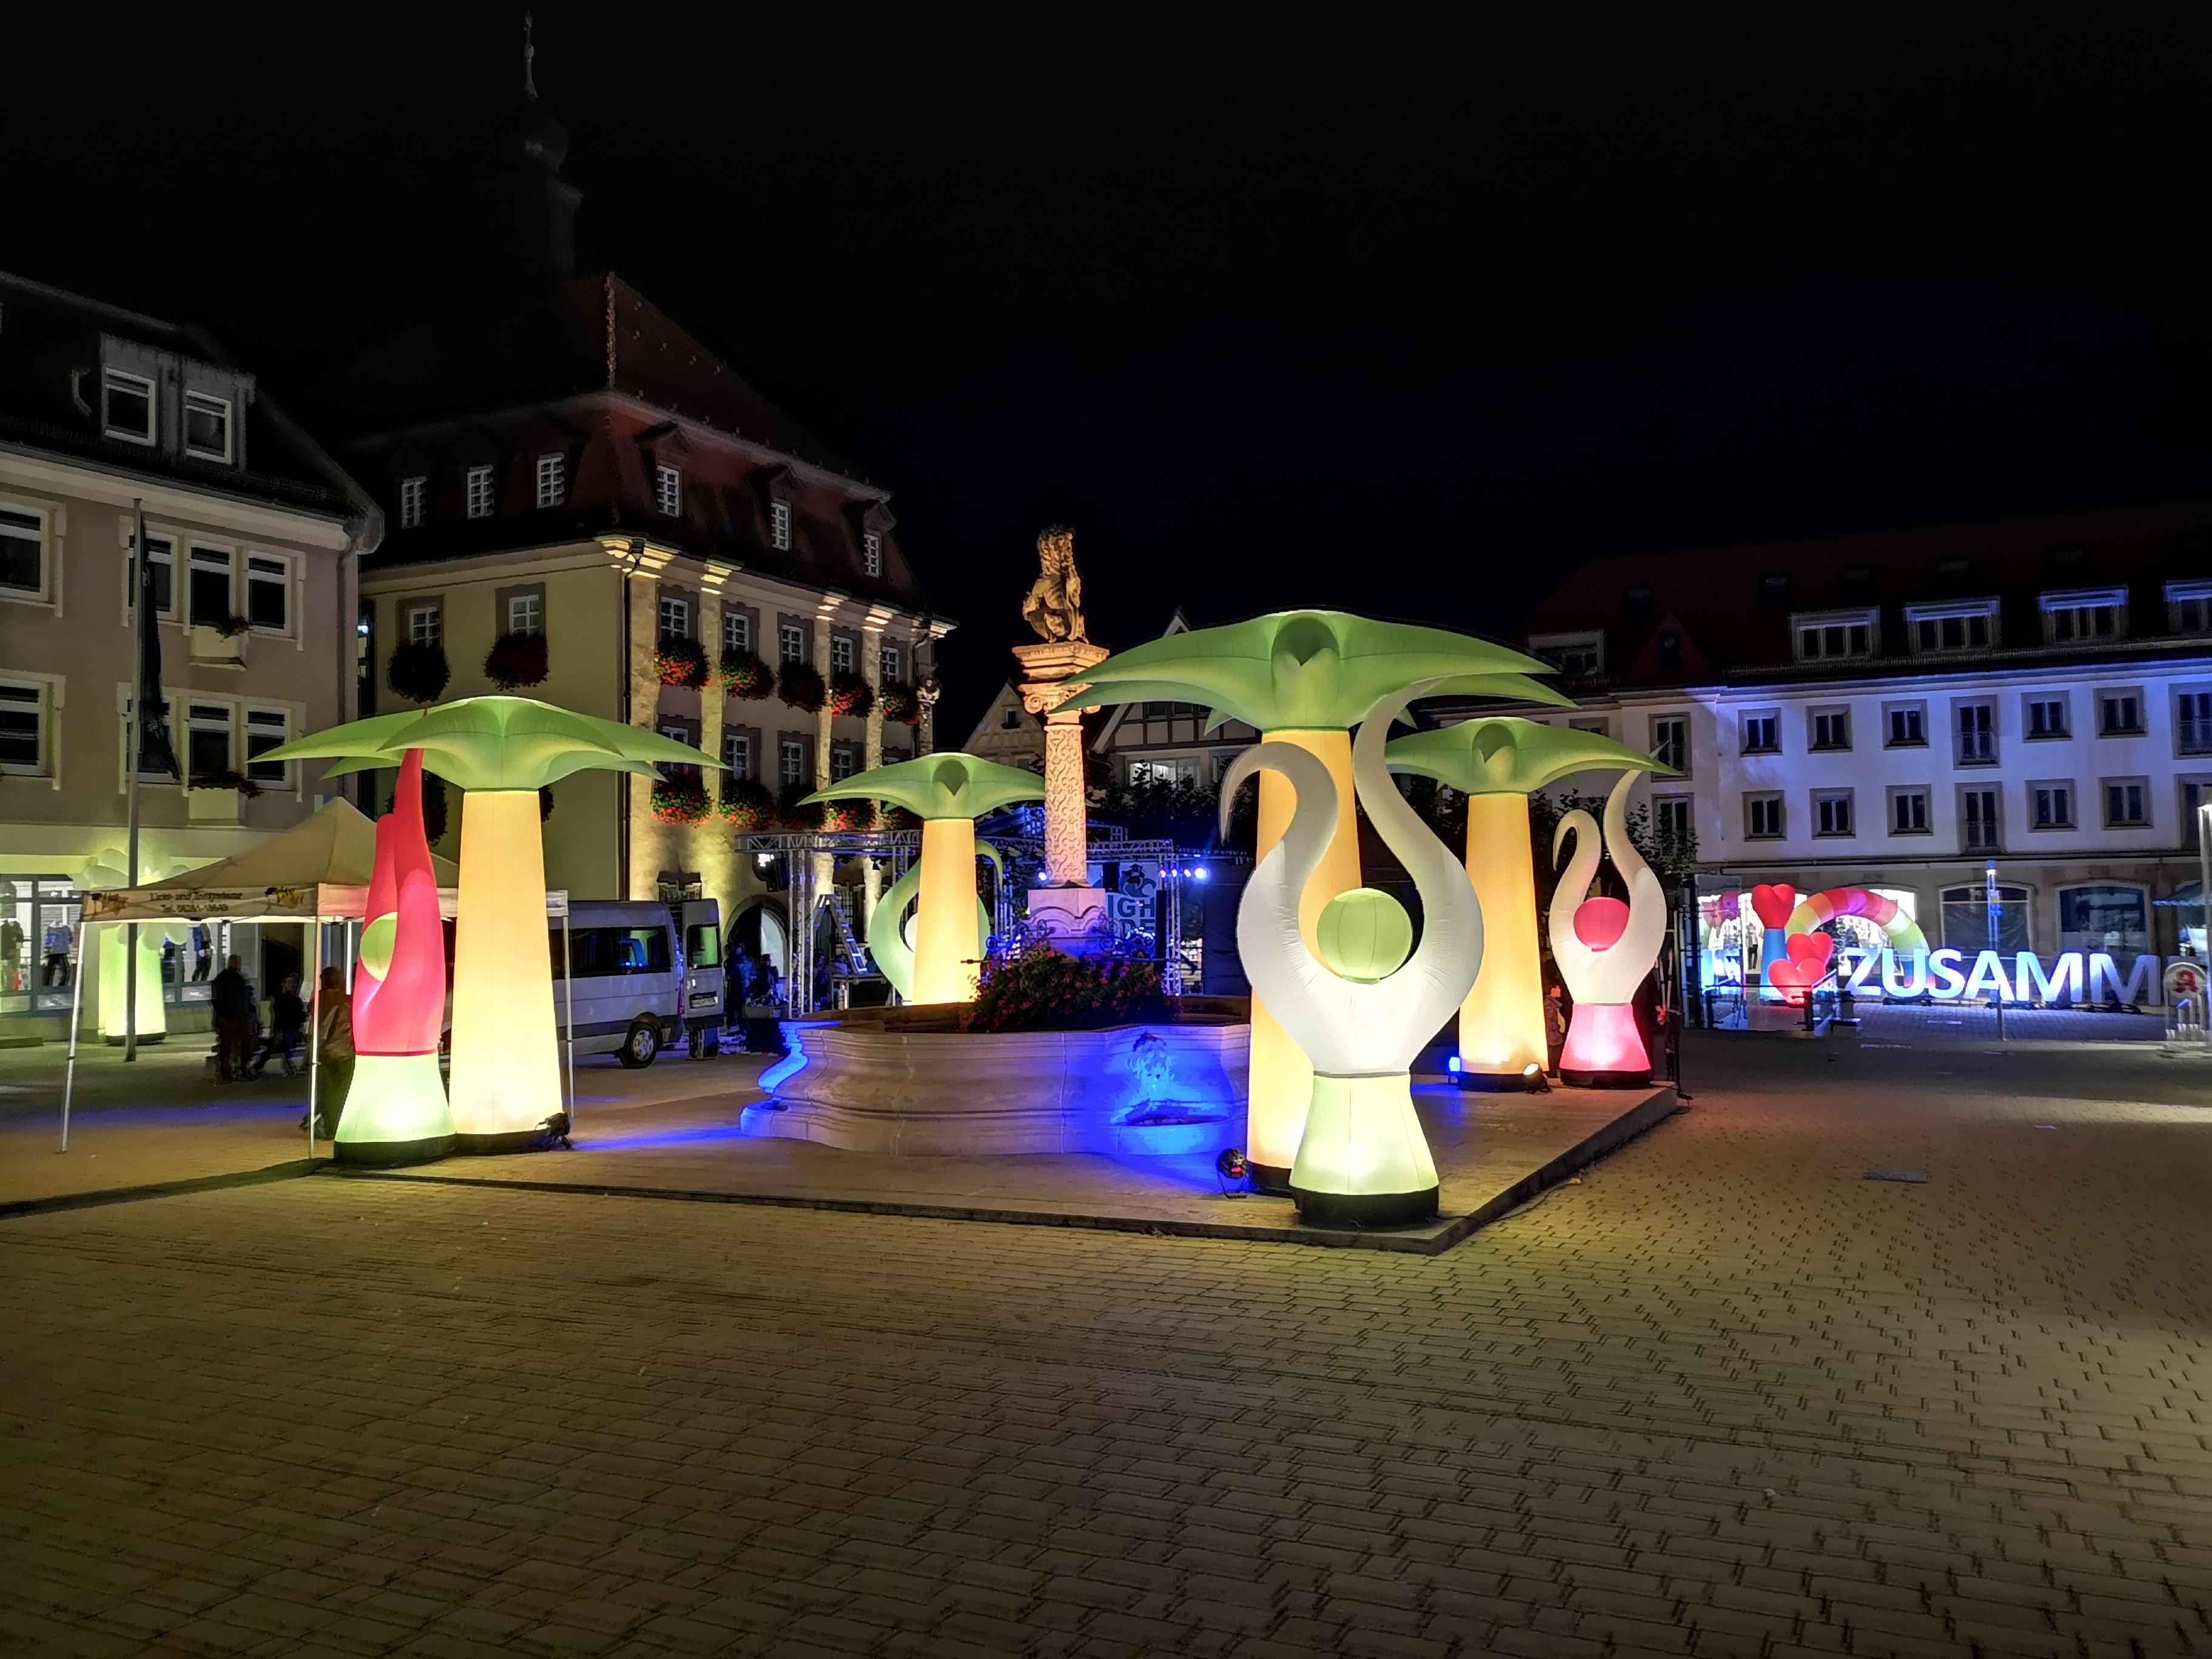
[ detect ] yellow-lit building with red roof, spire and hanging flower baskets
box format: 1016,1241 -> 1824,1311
318,71 -> 951,973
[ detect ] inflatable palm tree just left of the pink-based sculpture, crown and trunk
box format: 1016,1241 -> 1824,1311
1387,714 -> 1672,1088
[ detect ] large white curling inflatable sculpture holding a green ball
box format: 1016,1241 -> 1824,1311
1221,682 -> 1482,1225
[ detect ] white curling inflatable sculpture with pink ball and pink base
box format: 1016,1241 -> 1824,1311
1550,772 -> 1666,1088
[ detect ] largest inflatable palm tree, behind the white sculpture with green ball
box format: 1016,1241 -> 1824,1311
1064,611 -> 1573,1188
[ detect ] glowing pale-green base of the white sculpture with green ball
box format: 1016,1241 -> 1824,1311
1290,1071 -> 1438,1228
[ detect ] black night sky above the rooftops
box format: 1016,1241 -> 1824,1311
13,4 -> 2212,743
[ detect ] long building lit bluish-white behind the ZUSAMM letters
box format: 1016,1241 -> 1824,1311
1495,504 -> 2212,1000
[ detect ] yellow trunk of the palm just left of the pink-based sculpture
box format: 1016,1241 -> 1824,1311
1460,794 -> 1550,1084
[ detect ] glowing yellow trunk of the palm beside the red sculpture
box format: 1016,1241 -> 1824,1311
447,789 -> 562,1150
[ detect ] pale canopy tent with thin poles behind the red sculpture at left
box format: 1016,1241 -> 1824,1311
62,799 -> 575,1157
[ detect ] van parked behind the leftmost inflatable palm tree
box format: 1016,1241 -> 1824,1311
551,898 -> 723,1066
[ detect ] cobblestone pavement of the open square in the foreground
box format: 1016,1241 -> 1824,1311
0,1040 -> 2212,1657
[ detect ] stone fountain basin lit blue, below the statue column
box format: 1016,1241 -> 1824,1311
743,997 -> 1252,1157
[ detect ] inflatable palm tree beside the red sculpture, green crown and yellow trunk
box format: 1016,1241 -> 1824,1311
263,697 -> 714,1153
